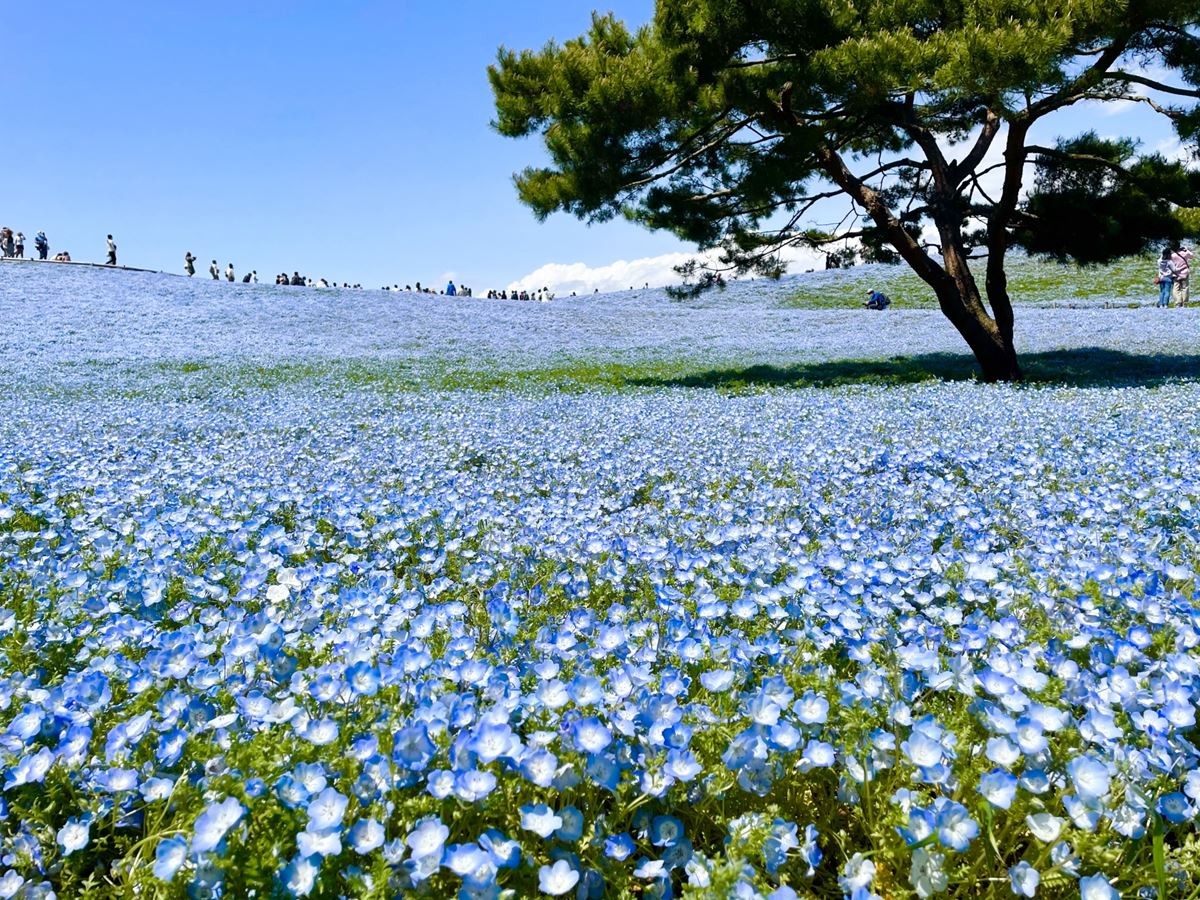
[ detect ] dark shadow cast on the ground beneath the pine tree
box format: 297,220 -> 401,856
628,347 -> 1200,391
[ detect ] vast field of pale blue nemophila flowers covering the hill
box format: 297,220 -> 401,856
0,264 -> 1200,900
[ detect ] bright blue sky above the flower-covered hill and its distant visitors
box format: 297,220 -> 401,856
0,0 -> 1170,289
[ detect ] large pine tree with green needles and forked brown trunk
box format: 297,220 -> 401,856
488,0 -> 1200,378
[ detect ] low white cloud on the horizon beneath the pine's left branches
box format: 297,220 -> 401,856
508,247 -> 824,296
